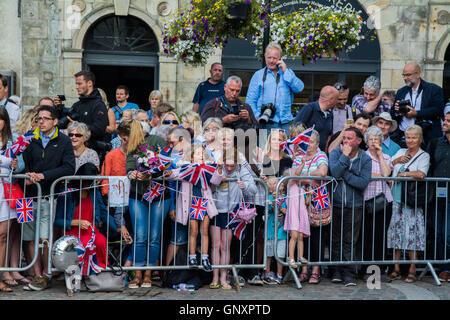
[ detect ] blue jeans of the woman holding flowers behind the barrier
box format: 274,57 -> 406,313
129,198 -> 170,267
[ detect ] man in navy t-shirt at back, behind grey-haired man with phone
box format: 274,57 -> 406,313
192,62 -> 225,114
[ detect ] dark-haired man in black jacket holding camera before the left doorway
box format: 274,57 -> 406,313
55,71 -> 110,158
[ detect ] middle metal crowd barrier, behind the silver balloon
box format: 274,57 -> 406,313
49,176 -> 268,291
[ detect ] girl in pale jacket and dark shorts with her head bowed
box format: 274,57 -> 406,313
209,148 -> 257,290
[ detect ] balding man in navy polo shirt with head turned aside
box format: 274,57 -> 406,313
294,86 -> 339,152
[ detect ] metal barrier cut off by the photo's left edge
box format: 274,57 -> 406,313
0,174 -> 43,273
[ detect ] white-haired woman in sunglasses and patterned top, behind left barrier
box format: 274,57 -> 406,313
67,121 -> 100,171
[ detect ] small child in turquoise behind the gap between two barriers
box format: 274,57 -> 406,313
263,177 -> 287,284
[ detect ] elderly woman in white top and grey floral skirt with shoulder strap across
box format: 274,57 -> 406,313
387,125 -> 430,283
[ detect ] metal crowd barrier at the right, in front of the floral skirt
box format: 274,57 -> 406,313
274,176 -> 450,289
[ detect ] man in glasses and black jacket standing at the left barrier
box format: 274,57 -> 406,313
23,106 -> 75,291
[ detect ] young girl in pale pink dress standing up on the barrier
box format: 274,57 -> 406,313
284,125 -> 309,268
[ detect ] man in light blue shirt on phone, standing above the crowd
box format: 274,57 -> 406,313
245,43 -> 304,138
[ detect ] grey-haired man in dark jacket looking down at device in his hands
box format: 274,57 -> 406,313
201,76 -> 256,130
